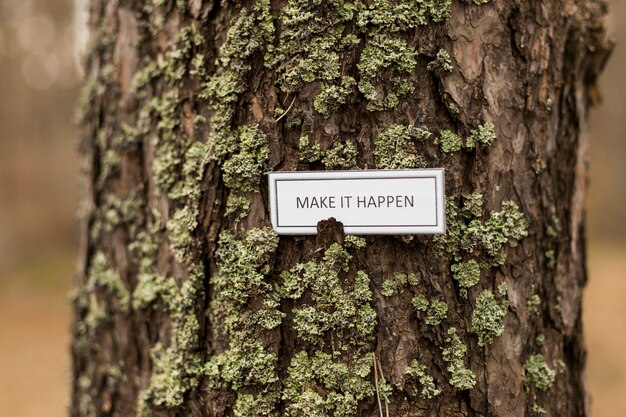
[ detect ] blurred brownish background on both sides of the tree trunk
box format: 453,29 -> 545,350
0,0 -> 626,417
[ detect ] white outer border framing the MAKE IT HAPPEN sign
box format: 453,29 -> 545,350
268,168 -> 446,235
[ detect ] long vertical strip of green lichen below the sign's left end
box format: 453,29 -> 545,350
204,224 -> 284,415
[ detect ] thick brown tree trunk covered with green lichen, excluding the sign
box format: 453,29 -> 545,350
71,0 -> 609,417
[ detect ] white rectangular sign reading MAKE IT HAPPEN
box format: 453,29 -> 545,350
269,169 -> 445,235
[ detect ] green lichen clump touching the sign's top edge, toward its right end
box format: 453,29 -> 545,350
374,125 -> 432,169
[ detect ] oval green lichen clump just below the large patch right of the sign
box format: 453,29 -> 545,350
470,290 -> 508,346
